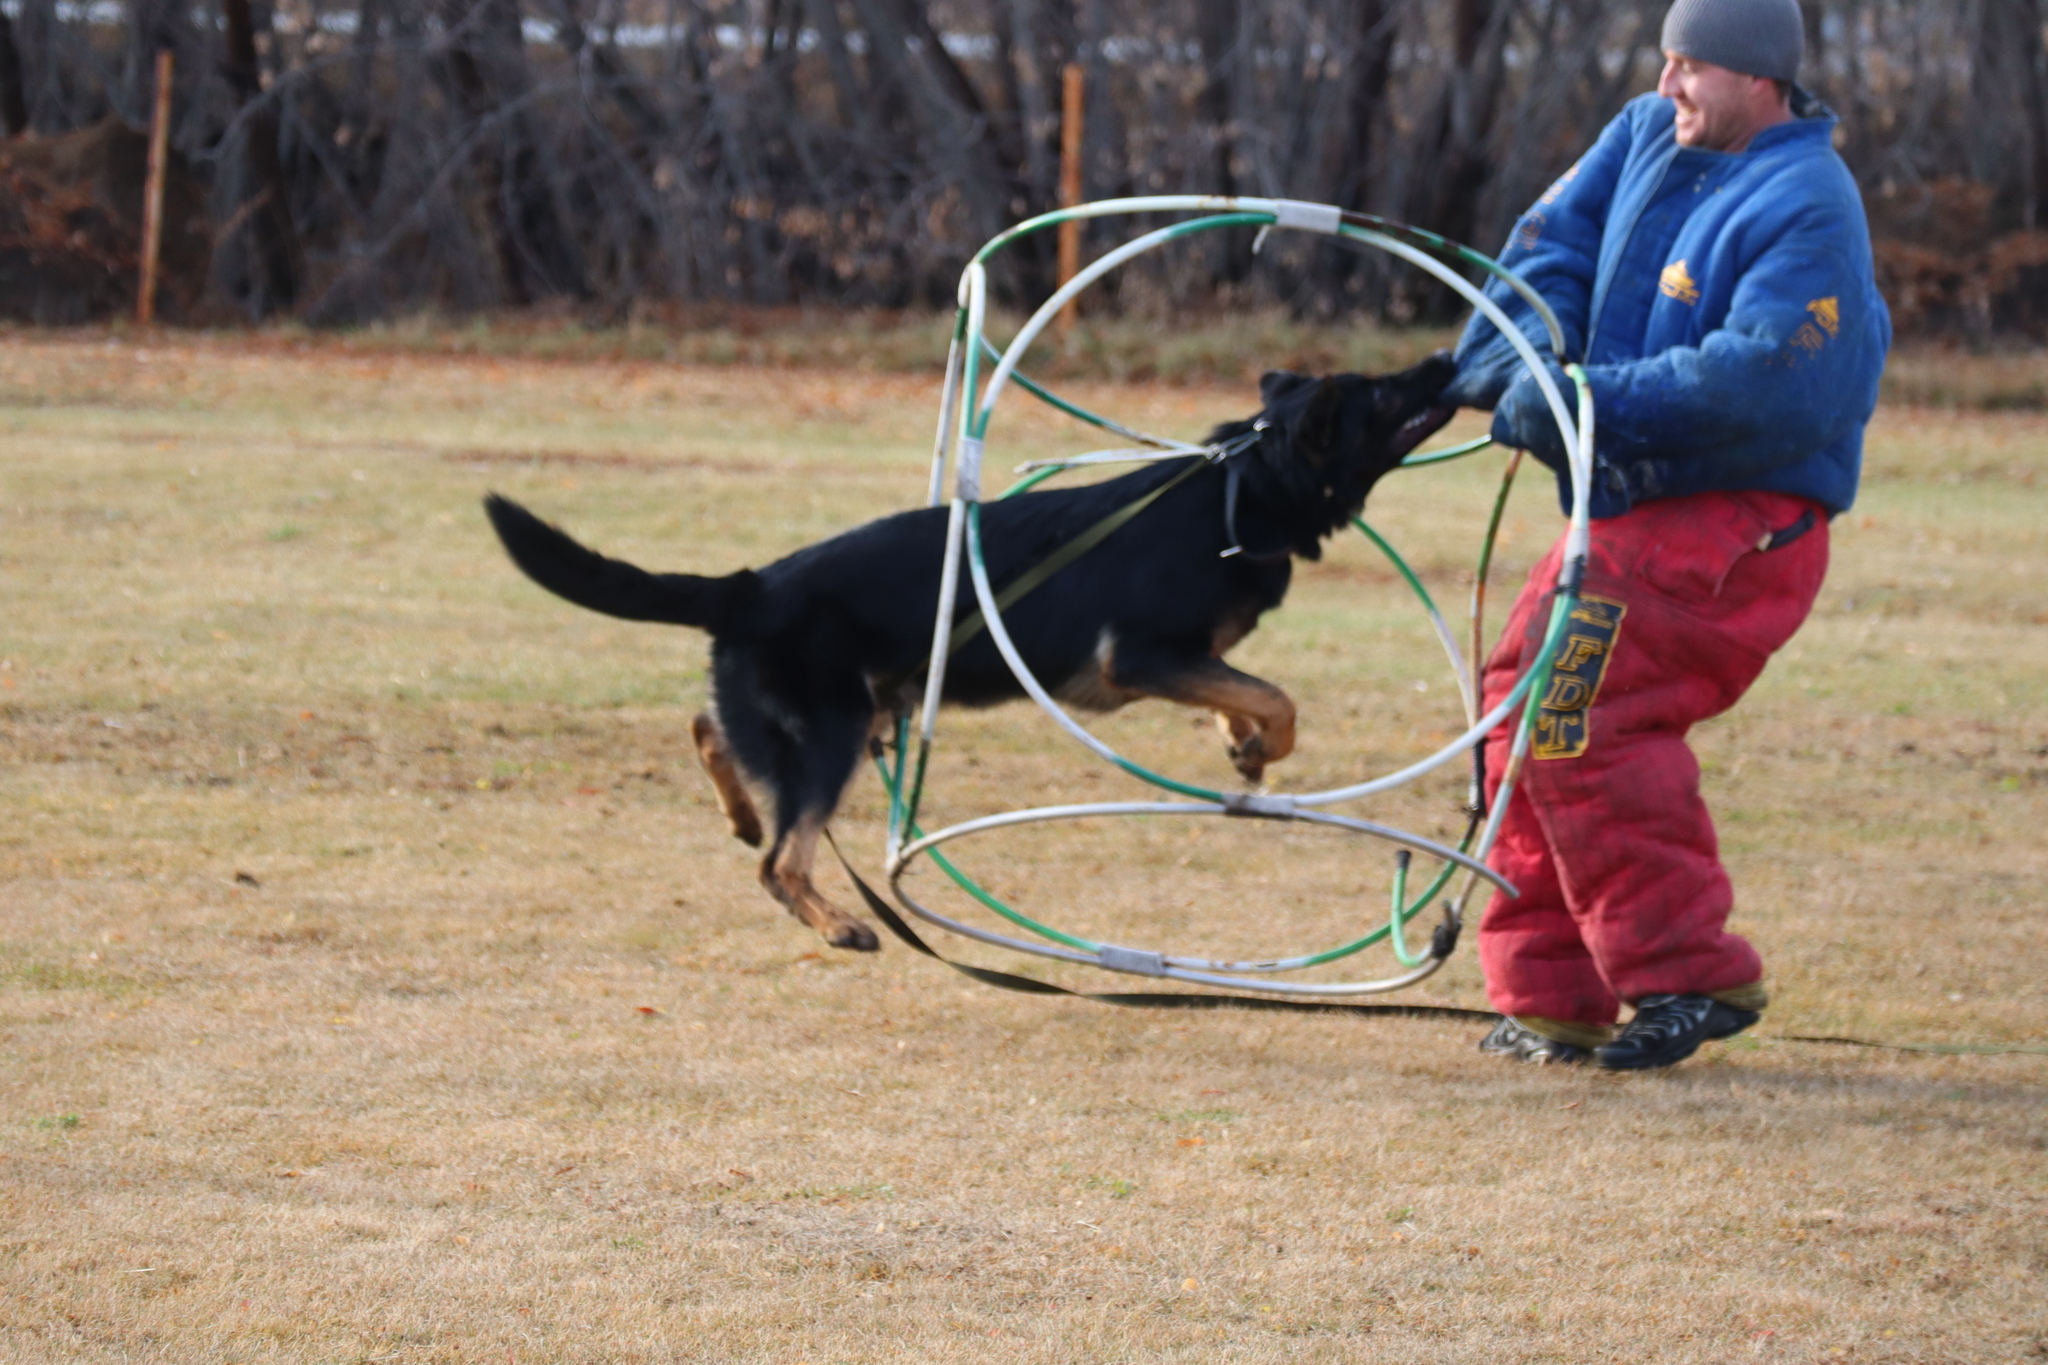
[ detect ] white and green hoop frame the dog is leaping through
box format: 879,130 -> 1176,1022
879,194 -> 1593,997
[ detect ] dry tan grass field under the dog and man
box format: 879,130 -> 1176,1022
0,332 -> 2048,1365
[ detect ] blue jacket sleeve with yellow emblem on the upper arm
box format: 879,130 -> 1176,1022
1493,187 -> 1890,501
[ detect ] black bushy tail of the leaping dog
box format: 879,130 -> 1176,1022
483,493 -> 762,634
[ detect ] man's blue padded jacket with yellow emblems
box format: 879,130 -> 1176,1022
1450,90 -> 1892,518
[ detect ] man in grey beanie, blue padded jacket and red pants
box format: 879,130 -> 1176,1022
1450,0 -> 1890,1070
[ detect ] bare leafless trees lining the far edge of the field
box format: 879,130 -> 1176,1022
0,0 -> 2048,329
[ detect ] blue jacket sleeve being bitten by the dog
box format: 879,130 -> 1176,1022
1444,111 -> 1632,407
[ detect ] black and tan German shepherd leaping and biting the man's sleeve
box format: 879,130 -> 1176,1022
483,354 -> 1454,950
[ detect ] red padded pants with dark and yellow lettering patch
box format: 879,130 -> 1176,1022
1479,493 -> 1827,1025
